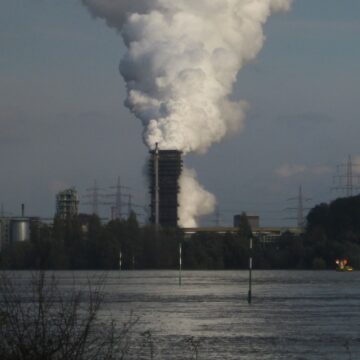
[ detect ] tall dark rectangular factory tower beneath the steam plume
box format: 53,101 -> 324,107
149,147 -> 182,227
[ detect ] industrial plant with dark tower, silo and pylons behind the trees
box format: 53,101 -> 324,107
0,145 -> 318,249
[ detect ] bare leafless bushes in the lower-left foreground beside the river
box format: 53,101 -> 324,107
0,272 -> 136,360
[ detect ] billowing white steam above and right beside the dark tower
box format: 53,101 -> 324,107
82,0 -> 291,226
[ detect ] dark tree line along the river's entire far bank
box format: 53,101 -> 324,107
0,196 -> 360,270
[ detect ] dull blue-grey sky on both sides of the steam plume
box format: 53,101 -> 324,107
0,0 -> 360,225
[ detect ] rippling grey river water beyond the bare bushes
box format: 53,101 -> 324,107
3,271 -> 360,360
